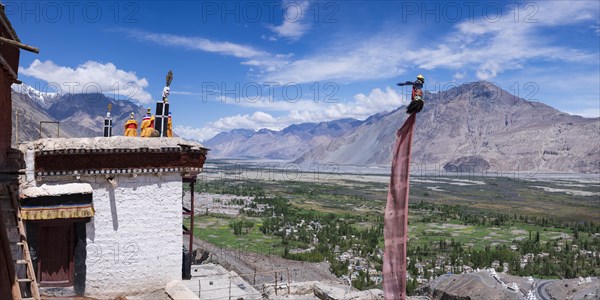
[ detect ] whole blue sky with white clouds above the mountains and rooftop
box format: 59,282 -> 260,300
3,0 -> 600,140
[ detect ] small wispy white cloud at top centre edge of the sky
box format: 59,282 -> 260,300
267,0 -> 310,41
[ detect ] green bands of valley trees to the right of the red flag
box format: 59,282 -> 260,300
408,202 -> 600,278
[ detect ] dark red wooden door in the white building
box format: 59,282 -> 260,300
38,223 -> 75,286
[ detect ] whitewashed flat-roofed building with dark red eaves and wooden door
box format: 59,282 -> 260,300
20,137 -> 207,297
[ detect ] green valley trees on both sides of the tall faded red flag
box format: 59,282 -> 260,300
252,198 -> 600,290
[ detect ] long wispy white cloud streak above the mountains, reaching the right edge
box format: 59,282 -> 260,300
264,1 -> 598,83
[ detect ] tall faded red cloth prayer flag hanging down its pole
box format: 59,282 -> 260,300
383,114 -> 416,300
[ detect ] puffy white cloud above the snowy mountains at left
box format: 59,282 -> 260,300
19,59 -> 152,103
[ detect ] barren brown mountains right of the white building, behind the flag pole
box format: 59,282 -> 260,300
205,81 -> 600,173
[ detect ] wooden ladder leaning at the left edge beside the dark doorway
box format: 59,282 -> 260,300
3,186 -> 40,300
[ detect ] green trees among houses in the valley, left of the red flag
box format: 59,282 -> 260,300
241,196 -> 383,287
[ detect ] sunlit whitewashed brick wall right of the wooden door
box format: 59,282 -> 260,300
80,173 -> 182,297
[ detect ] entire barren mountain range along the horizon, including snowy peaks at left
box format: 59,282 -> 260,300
12,81 -> 600,173
